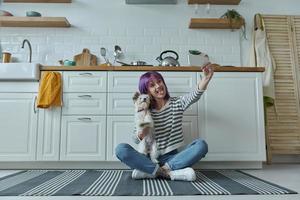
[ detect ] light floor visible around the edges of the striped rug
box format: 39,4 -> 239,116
0,164 -> 300,200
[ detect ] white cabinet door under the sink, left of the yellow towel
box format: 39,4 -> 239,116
0,93 -> 38,161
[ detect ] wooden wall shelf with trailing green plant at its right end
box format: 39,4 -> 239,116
189,18 -> 245,29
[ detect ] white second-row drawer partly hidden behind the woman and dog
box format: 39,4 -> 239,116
107,93 -> 198,115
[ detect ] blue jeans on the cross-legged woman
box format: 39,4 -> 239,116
116,139 -> 208,175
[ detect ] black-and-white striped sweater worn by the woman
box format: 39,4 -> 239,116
135,90 -> 203,155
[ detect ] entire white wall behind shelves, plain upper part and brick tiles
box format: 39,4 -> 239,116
0,0 -> 300,66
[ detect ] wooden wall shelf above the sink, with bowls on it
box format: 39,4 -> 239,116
0,16 -> 71,27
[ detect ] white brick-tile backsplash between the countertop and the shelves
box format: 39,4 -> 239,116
0,27 -> 240,65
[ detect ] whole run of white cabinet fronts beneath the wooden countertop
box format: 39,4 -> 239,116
0,71 -> 265,166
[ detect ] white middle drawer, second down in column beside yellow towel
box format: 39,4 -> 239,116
62,93 -> 106,115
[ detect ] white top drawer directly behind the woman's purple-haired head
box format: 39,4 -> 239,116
108,72 -> 197,93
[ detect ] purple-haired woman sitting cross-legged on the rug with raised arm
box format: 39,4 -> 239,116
116,64 -> 214,181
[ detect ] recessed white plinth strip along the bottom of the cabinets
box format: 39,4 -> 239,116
0,161 -> 262,169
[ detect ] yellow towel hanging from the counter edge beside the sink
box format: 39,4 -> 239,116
37,72 -> 62,108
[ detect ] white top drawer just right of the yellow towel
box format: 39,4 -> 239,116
63,71 -> 107,92
